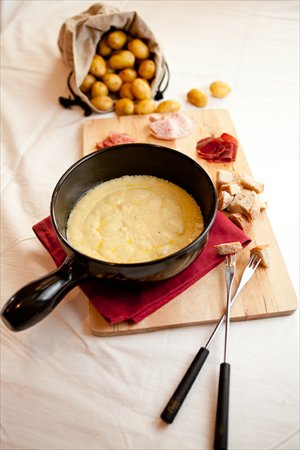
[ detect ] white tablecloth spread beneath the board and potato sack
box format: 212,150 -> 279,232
1,0 -> 299,450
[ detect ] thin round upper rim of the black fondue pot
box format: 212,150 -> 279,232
50,142 -> 218,268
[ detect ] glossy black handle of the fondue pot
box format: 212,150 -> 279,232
1,257 -> 91,331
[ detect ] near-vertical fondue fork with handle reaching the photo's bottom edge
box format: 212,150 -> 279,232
214,254 -> 236,450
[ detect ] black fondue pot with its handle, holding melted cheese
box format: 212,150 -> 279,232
1,143 -> 217,331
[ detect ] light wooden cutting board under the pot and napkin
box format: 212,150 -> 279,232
83,109 -> 298,336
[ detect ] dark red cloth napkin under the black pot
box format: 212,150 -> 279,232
33,211 -> 251,324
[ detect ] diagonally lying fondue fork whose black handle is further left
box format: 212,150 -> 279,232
160,255 -> 260,423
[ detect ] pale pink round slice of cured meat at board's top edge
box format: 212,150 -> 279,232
148,112 -> 195,140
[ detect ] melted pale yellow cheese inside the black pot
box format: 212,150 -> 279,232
67,175 -> 204,263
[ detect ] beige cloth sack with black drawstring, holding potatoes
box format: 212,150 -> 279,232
58,3 -> 169,116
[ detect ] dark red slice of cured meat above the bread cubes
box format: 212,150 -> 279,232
196,133 -> 238,162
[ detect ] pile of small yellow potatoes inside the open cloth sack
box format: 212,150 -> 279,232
80,30 -> 156,115
